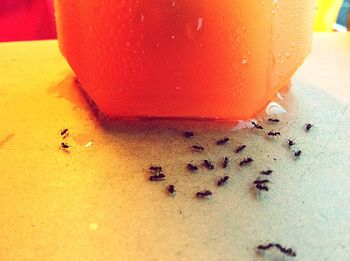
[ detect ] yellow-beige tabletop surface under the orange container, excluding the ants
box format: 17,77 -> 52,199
0,33 -> 350,261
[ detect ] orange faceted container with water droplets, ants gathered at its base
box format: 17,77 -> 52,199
55,0 -> 314,120
